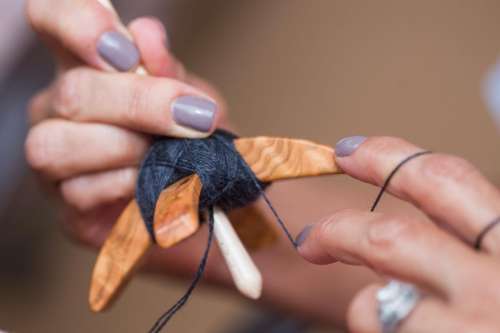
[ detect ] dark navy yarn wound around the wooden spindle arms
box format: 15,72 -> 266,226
136,130 -> 267,232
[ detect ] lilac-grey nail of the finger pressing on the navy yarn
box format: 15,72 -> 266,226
172,96 -> 217,132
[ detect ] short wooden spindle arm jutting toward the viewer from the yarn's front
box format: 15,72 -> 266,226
153,174 -> 202,248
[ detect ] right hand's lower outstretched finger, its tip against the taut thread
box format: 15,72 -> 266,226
297,210 -> 481,297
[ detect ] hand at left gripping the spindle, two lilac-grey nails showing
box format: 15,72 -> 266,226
26,0 -> 223,270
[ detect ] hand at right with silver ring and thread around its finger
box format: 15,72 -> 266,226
298,137 -> 500,333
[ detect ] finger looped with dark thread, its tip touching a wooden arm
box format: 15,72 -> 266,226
336,137 -> 500,253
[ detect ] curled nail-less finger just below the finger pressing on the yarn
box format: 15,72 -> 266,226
26,119 -> 149,180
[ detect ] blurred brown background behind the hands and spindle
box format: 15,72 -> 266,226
0,0 -> 500,333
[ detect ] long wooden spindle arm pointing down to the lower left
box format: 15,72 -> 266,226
89,200 -> 152,312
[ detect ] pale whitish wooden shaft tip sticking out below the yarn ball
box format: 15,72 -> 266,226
214,207 -> 262,299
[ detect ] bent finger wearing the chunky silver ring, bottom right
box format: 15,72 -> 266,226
347,285 -> 465,333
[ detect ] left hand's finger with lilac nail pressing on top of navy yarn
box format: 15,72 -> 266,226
50,67 -> 220,138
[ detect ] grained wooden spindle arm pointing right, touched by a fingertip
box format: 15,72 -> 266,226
234,137 -> 341,181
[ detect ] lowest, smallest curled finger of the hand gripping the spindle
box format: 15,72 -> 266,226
61,167 -> 138,211
